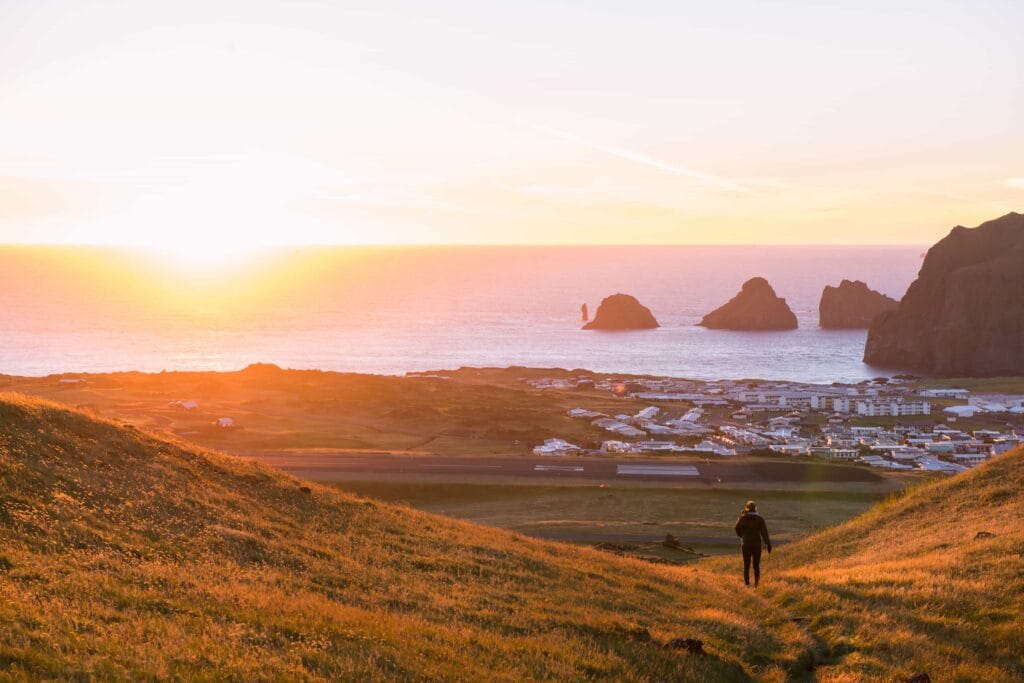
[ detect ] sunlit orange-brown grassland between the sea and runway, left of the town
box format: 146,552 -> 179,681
0,366 -> 655,456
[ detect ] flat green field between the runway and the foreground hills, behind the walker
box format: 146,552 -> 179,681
338,481 -> 888,554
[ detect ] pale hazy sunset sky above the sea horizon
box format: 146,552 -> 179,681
0,0 -> 1024,250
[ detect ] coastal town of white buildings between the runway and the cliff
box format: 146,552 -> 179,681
524,376 -> 1024,474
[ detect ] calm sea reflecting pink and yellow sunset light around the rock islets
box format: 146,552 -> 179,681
0,247 -> 925,382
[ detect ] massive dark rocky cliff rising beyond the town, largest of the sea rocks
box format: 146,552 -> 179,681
864,213 -> 1024,377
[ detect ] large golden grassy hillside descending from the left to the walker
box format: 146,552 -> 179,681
0,395 -> 810,681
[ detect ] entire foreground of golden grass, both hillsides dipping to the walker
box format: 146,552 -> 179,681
0,395 -> 1024,681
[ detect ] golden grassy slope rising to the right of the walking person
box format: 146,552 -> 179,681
745,450 -> 1024,681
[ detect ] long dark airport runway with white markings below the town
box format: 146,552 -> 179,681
239,453 -> 881,483
